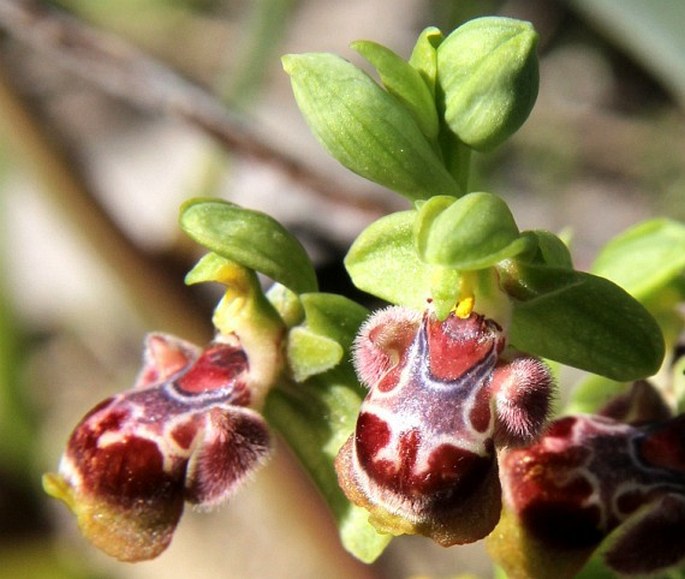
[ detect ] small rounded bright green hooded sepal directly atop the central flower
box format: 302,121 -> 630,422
415,193 -> 528,271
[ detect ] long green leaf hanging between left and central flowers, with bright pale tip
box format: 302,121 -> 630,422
265,367 -> 391,563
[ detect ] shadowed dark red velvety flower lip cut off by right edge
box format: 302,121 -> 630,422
489,388 -> 685,578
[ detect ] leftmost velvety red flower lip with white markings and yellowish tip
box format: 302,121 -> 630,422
44,334 -> 270,561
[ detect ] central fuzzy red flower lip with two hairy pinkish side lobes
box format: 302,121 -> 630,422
336,307 -> 552,546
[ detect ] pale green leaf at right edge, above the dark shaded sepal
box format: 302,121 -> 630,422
592,219 -> 685,301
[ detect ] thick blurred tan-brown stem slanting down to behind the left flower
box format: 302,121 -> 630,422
0,51 -> 211,343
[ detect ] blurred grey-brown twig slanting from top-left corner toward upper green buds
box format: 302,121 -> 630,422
0,0 -> 388,217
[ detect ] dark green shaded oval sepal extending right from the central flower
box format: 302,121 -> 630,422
497,260 -> 664,381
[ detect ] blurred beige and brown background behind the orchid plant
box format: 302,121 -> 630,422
0,0 -> 685,579
